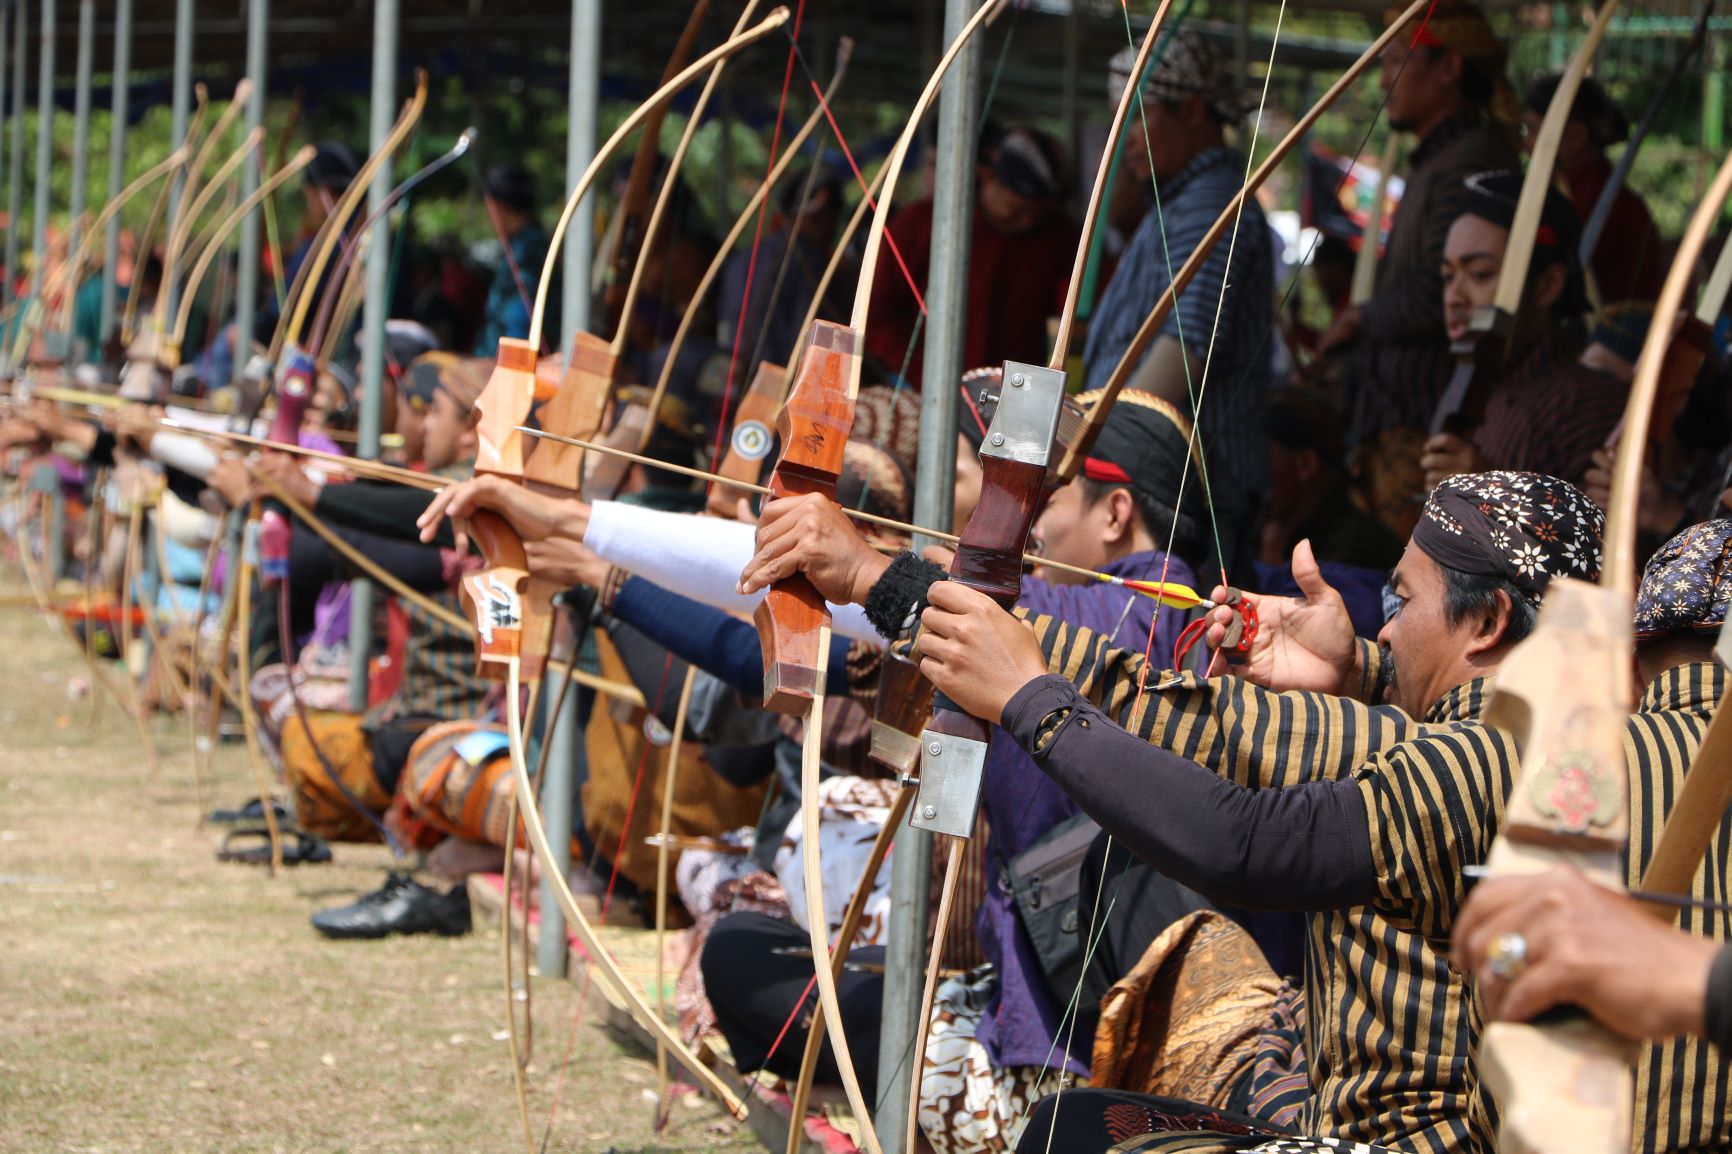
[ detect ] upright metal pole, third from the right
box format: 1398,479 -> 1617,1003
346,0 -> 396,712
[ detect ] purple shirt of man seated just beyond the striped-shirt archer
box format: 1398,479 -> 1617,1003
975,551 -> 1204,1076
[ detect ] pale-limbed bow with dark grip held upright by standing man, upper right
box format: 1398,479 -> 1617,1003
1431,0 -> 1619,438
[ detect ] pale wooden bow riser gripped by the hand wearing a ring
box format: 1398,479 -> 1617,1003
1481,579 -> 1633,1154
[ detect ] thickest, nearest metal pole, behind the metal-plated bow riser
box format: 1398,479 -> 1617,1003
876,0 -> 980,1154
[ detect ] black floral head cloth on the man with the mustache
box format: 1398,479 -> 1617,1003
1413,470 -> 1606,605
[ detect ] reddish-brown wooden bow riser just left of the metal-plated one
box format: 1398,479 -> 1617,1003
752,321 -> 859,714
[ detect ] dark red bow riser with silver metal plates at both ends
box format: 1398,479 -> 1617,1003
909,362 -> 1065,837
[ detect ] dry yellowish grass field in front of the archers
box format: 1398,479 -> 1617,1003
0,592 -> 755,1154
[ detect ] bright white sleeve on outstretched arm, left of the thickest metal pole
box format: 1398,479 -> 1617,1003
584,501 -> 883,646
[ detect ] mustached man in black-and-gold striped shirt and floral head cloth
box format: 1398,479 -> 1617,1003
741,473 -> 1602,1152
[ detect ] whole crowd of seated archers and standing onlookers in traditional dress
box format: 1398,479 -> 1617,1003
0,0 -> 1732,1154
